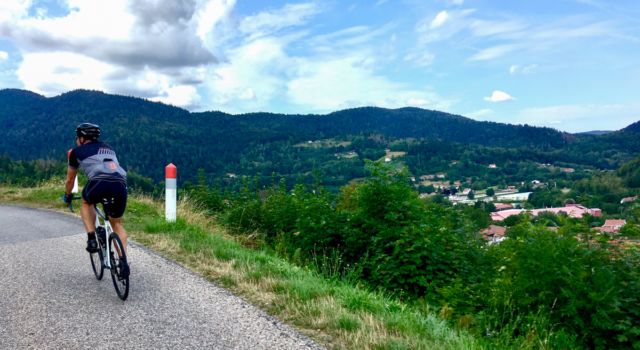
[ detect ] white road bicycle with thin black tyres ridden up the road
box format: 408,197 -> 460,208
68,197 -> 129,300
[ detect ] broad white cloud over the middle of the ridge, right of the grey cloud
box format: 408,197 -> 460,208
206,2 -> 438,113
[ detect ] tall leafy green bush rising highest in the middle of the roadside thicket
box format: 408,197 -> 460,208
339,163 -> 486,301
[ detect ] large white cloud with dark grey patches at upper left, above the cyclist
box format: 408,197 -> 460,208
0,0 -> 235,107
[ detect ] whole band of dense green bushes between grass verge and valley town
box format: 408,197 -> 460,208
189,163 -> 640,349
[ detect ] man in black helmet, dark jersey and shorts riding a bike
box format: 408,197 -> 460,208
63,123 -> 129,276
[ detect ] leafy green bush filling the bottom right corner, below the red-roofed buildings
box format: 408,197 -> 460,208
484,223 -> 640,348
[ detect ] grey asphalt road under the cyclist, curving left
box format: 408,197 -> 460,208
0,205 -> 320,349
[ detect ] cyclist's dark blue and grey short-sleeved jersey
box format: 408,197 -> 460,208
69,141 -> 127,181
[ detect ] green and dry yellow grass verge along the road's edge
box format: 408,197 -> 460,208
0,181 -> 482,349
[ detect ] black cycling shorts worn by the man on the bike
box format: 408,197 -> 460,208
82,179 -> 127,219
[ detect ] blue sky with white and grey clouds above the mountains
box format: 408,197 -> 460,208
0,0 -> 640,132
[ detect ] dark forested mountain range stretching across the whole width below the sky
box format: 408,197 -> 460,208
0,90 -> 640,190
